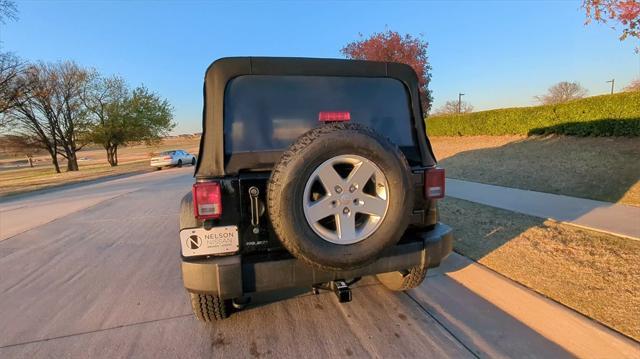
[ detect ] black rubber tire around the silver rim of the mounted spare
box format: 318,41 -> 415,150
268,123 -> 413,271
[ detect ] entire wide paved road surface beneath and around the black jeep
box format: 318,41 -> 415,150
0,167 -> 640,358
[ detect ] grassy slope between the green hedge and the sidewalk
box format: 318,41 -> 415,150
430,136 -> 640,206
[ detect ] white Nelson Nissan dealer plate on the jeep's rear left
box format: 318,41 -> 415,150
180,226 -> 240,257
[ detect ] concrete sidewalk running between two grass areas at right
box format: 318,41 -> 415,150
446,178 -> 640,240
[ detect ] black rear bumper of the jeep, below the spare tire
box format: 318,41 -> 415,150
182,223 -> 453,299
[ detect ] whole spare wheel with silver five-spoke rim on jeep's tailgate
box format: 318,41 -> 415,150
267,123 -> 413,270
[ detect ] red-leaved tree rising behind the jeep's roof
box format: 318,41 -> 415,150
341,30 -> 431,114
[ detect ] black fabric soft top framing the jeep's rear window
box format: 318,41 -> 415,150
195,57 -> 436,178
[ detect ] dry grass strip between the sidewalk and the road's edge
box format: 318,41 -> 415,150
440,198 -> 640,340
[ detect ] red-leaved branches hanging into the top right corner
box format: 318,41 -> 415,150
582,0 -> 640,45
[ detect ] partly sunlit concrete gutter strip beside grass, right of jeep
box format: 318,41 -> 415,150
418,253 -> 640,358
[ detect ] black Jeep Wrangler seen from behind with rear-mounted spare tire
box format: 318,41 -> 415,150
180,57 -> 452,321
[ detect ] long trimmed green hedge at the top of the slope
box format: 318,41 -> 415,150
426,92 -> 640,136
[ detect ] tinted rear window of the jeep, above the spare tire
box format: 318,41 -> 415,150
224,75 -> 414,154
